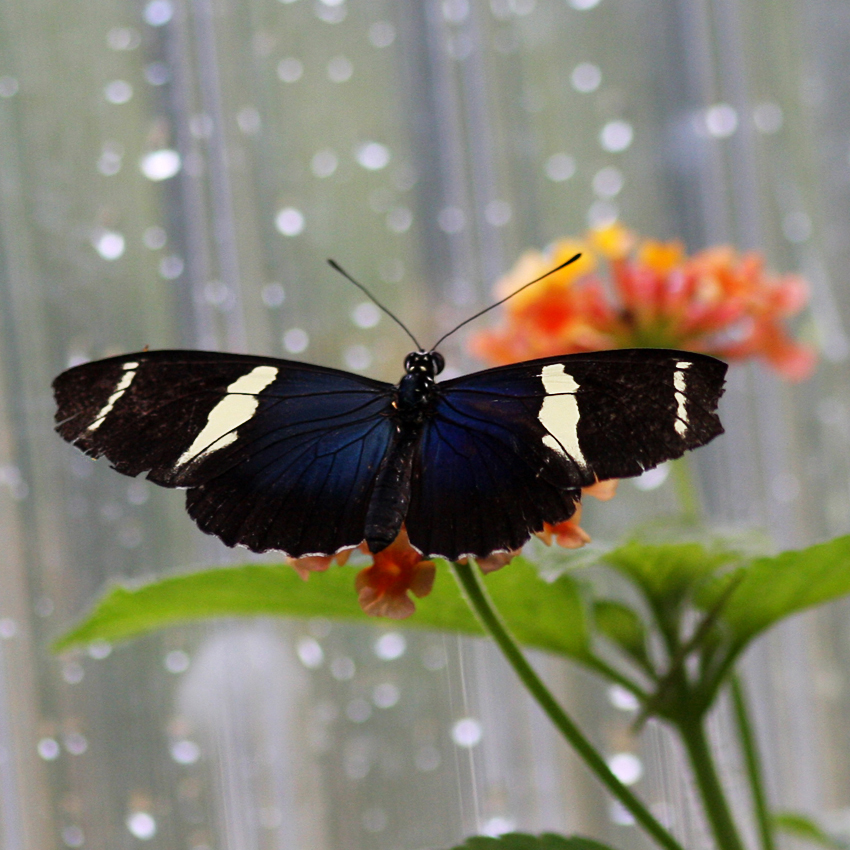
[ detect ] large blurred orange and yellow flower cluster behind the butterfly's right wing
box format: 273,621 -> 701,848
471,224 -> 816,380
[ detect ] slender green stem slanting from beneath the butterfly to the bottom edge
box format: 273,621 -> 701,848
452,563 -> 688,850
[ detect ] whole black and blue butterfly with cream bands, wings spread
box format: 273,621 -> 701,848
54,349 -> 726,559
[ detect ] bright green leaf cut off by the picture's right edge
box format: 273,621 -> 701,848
702,536 -> 850,650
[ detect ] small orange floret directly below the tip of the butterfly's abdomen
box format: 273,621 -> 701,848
354,528 -> 436,620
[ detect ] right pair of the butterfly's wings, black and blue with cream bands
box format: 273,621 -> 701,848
406,349 -> 726,558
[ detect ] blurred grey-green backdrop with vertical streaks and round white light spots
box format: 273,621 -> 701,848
0,0 -> 850,850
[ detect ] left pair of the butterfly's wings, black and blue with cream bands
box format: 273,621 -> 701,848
54,351 -> 394,557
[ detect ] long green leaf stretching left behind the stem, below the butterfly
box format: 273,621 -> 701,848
54,558 -> 589,659
